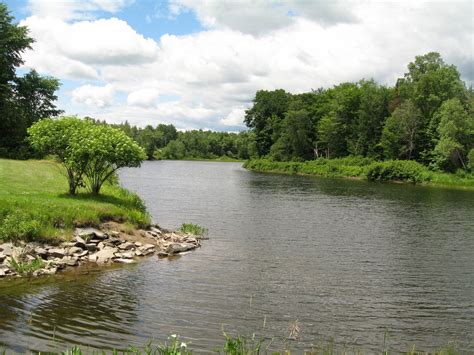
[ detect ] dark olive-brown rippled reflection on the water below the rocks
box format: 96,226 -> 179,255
0,265 -> 143,352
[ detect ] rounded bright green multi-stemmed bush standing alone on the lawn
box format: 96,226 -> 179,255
28,117 -> 146,194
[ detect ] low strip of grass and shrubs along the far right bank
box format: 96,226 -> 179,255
244,157 -> 474,190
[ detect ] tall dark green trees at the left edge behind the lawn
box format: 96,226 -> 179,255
0,3 -> 61,158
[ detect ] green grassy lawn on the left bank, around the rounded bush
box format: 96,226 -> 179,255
0,159 -> 150,245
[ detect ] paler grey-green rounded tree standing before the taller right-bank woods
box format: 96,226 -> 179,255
381,101 -> 421,159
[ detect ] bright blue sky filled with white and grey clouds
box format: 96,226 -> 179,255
3,0 -> 474,131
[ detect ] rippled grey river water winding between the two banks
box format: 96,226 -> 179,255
0,161 -> 474,353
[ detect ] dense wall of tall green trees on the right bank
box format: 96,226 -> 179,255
245,52 -> 474,171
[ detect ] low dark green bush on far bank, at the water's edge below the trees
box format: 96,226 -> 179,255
367,160 -> 431,184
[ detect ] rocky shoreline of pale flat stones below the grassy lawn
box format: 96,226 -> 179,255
0,223 -> 203,278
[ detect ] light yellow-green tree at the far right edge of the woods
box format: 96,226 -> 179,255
434,99 -> 474,170
